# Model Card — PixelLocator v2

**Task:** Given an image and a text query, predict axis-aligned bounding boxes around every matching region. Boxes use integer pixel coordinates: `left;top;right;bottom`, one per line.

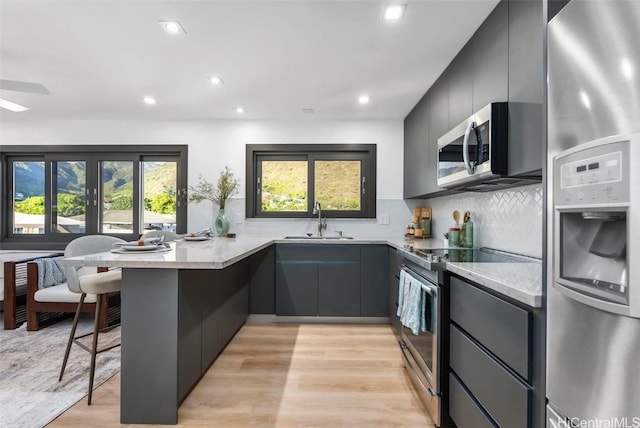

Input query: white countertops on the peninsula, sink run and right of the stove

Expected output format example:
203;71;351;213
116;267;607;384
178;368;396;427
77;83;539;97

64;235;542;307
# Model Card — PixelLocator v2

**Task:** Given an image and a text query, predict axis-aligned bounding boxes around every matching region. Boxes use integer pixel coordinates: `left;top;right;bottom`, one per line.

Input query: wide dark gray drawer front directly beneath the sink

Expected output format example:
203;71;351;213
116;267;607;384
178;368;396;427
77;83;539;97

276;244;360;262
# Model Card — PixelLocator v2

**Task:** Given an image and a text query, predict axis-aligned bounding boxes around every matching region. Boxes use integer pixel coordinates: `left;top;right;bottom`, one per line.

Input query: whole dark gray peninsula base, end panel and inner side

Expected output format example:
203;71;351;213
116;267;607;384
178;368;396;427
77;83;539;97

120;261;249;425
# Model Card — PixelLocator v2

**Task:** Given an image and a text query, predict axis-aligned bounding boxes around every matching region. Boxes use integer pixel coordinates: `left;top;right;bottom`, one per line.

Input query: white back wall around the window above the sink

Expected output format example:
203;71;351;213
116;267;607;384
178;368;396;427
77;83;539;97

0;119;410;236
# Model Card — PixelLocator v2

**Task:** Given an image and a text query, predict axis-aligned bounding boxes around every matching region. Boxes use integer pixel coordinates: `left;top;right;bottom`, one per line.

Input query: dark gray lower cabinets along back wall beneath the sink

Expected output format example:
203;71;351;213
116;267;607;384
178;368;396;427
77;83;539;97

275;244;388;317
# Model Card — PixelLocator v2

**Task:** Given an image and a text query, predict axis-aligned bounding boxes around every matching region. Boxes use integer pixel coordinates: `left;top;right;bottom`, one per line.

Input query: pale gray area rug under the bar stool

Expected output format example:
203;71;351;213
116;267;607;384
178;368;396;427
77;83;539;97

0;318;120;428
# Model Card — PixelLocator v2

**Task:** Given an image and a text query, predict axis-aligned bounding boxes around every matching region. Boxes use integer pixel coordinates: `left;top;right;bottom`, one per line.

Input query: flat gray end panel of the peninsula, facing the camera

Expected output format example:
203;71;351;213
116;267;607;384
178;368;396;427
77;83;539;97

120;269;180;425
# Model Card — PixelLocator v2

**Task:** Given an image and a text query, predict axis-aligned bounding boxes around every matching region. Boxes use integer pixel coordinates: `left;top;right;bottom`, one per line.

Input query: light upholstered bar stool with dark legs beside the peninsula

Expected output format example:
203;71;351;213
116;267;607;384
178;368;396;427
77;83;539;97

58;235;125;405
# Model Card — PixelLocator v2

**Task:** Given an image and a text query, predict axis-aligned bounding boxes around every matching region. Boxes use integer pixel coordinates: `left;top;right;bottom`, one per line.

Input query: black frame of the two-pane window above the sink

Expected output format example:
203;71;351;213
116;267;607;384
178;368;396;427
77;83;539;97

245;144;377;219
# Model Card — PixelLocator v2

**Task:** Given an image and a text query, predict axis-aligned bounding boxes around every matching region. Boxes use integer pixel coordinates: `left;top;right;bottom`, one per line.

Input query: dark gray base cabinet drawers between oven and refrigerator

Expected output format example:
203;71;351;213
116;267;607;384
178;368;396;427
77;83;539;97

449;276;535;428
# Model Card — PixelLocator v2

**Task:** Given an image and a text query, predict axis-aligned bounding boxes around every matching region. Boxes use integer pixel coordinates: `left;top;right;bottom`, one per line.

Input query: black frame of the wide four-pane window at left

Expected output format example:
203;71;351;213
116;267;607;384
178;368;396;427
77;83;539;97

0;144;188;250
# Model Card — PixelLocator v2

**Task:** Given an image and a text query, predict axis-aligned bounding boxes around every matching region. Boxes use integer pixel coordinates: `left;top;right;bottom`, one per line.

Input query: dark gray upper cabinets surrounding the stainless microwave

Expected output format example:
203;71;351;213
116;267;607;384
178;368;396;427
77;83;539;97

404;0;544;198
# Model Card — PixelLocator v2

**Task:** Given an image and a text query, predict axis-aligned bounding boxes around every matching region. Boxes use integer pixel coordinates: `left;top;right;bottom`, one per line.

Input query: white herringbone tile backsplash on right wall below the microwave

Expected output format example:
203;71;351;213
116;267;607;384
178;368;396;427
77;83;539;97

409;184;542;257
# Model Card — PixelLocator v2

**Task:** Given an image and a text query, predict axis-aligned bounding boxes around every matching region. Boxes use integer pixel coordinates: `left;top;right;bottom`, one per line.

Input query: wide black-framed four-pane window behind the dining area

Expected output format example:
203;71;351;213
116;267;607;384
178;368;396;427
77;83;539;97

1;146;187;248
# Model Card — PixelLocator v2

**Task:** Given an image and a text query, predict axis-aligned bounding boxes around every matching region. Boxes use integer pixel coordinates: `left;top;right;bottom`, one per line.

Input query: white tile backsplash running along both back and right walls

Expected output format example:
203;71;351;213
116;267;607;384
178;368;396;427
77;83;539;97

189;184;542;257
